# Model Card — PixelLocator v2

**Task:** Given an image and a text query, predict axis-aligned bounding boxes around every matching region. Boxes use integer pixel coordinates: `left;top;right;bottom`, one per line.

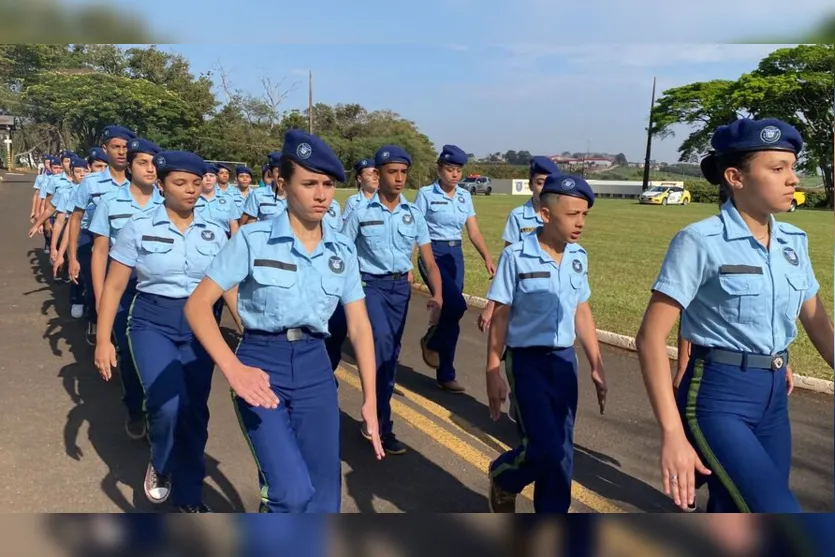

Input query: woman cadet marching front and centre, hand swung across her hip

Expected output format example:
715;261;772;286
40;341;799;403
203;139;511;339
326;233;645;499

185;129;384;513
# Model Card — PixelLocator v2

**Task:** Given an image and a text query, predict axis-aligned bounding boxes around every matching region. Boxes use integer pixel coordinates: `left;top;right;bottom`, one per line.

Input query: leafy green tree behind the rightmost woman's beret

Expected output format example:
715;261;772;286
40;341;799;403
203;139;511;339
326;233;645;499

652;44;835;207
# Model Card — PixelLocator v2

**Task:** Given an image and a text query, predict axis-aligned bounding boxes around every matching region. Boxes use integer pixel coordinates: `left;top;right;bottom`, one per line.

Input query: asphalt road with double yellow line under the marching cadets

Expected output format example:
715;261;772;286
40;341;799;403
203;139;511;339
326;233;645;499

0;175;835;513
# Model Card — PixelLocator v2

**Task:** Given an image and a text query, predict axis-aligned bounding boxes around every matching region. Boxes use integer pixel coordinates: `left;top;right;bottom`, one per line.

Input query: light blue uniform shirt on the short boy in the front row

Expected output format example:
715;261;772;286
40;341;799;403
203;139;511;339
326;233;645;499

487;228;591;348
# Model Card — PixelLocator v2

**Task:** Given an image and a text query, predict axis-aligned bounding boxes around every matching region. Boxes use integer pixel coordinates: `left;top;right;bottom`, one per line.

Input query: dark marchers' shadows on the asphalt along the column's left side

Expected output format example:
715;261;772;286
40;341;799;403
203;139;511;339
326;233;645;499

30;249;244;513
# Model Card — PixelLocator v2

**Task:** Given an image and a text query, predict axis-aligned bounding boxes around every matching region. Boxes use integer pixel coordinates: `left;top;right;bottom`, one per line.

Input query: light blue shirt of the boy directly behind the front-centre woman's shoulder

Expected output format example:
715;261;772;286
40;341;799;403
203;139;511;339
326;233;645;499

342;193;430;275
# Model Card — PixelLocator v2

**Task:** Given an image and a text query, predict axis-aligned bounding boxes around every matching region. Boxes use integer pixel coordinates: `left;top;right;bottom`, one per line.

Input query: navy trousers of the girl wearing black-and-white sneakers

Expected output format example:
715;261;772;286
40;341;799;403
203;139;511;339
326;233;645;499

128;292;214;505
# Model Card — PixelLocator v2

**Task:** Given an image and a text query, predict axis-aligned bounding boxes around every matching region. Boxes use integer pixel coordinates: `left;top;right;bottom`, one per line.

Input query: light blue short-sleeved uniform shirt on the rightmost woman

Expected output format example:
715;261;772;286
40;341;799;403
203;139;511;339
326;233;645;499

652;201;820;355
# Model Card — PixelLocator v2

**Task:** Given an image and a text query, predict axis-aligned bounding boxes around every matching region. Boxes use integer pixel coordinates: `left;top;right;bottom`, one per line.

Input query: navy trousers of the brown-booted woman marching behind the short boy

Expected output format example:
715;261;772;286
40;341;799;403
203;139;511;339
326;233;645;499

418;241;467;383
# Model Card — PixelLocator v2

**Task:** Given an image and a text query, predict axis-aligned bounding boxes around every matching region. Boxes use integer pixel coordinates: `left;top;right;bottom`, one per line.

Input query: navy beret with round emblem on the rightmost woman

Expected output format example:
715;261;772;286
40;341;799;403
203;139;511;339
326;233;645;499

710;118;803;156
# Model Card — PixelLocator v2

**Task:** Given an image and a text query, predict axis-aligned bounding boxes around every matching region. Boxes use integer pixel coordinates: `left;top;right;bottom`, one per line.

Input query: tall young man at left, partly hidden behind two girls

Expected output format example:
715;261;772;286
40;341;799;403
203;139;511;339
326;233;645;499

67;126;136;345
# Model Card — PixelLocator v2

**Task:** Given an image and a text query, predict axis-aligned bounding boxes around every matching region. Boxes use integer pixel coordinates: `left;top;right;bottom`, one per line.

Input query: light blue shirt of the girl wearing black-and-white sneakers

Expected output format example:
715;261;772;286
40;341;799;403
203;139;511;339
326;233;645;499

110;205;227;298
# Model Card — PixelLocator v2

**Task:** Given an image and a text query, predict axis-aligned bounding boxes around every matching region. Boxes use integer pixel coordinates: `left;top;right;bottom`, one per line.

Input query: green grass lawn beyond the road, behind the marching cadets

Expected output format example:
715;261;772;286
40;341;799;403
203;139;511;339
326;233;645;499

337;191;833;380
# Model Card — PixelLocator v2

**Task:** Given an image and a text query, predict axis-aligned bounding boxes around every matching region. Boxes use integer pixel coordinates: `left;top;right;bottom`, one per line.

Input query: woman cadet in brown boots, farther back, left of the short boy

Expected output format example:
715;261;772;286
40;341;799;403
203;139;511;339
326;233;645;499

415;145;496;393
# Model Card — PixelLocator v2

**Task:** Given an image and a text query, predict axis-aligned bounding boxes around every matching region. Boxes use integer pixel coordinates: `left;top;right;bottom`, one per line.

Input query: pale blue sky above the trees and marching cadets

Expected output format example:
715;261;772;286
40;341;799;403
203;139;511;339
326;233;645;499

58;0;833;162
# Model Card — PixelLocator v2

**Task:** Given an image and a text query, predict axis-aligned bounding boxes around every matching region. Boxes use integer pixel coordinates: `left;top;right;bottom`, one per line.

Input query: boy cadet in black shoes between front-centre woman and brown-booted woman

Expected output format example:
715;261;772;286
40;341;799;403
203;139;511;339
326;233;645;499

342;145;443;455
